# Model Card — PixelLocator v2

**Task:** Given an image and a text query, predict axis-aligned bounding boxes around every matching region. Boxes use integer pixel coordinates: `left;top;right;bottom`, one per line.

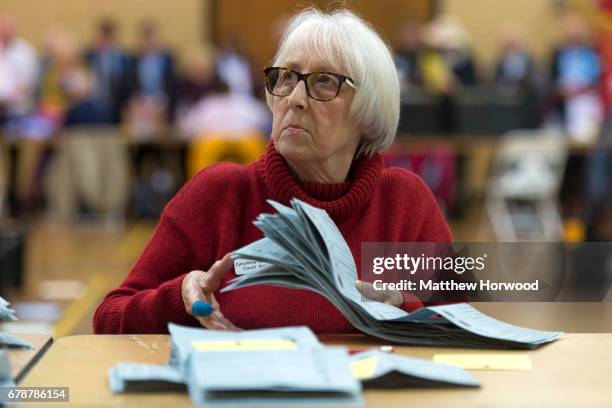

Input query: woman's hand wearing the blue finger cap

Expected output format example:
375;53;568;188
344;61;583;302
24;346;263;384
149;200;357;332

181;254;240;330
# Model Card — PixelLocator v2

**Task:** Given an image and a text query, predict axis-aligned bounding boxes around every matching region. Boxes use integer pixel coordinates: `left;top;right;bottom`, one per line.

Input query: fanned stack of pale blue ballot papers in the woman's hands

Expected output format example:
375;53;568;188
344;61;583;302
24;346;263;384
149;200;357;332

221;199;563;348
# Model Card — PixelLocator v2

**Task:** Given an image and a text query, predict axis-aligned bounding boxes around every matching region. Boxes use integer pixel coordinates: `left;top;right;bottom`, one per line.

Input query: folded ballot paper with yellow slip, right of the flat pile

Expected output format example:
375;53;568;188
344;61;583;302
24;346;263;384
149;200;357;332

351;350;480;388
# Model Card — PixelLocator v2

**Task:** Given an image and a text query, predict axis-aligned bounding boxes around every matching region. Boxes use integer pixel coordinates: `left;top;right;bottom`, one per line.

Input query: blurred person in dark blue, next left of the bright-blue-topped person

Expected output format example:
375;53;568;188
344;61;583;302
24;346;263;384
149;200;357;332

494;23;534;94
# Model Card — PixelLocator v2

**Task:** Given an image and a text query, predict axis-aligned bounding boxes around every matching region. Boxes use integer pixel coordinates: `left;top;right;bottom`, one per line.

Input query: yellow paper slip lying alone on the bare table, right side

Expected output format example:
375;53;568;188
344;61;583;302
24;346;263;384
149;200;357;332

433;353;533;370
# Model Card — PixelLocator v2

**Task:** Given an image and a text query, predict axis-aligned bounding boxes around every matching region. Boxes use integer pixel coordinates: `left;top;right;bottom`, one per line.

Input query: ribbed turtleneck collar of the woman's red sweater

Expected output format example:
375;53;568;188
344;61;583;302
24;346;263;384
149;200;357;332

264;141;383;222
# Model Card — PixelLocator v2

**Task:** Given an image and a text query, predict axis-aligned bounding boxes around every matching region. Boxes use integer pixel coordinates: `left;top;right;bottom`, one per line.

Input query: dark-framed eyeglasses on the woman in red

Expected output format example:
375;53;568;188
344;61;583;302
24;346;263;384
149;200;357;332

264;67;357;102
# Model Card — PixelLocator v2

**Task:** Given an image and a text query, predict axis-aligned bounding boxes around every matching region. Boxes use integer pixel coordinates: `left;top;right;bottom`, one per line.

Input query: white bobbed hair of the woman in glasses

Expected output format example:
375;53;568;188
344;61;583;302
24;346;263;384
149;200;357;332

266;8;400;157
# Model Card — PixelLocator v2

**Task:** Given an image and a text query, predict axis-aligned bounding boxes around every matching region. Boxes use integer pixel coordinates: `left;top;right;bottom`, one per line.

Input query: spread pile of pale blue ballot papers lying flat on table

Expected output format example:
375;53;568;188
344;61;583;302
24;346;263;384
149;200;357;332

109;324;479;406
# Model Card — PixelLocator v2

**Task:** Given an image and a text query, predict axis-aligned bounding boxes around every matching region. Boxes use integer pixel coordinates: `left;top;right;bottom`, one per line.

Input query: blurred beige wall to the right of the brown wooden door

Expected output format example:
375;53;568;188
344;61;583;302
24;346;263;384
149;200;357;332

440;0;560;73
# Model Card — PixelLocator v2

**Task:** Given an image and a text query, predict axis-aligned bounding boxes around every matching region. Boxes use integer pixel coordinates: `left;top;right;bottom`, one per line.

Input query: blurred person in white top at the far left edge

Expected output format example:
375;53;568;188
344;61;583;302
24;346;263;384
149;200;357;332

0;15;38;125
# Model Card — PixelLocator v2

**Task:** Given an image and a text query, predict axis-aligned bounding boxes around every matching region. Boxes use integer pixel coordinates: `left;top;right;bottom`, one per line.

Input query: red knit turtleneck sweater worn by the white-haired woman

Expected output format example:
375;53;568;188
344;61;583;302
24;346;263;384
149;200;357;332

94;143;451;334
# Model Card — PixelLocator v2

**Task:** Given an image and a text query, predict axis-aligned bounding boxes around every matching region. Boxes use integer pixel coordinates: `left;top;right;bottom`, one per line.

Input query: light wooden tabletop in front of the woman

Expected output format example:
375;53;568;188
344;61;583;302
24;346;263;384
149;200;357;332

20;333;612;407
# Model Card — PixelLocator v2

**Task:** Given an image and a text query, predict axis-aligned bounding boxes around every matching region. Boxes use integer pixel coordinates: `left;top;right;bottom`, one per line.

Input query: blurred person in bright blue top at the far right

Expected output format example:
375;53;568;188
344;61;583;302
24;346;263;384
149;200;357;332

551;13;603;141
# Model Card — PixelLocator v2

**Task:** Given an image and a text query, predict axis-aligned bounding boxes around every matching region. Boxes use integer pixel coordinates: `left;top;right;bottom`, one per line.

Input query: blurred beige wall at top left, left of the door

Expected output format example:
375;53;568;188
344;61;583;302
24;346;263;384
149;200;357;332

0;0;210;50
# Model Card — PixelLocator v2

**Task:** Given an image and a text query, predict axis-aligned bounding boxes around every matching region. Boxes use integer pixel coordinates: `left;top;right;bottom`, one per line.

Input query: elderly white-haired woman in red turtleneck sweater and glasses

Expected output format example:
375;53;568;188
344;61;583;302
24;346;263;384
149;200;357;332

94;9;451;333
